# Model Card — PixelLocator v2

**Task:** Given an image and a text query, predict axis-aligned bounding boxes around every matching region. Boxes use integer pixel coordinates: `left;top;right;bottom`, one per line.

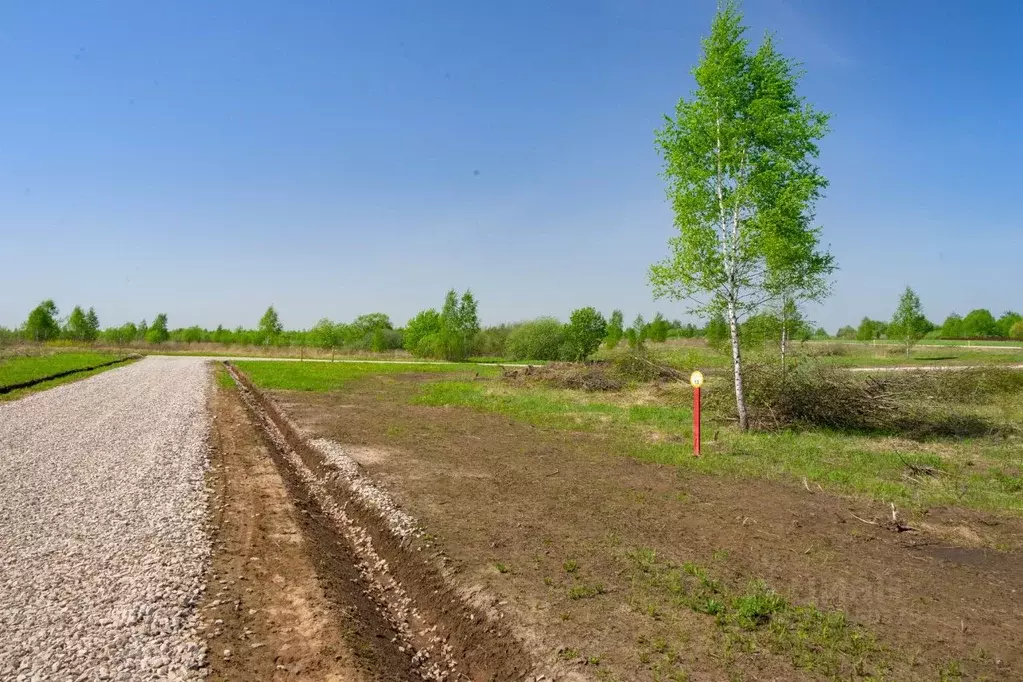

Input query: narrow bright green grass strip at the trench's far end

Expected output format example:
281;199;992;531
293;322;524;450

234;360;499;392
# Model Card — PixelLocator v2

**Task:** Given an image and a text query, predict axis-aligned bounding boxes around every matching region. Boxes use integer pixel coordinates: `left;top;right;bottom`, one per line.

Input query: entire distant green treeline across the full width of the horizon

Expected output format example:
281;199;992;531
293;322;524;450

0;290;1023;360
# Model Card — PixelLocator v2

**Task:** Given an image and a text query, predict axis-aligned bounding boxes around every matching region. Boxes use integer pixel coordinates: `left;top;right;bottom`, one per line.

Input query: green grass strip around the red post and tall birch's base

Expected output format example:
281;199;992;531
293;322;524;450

414;380;1023;512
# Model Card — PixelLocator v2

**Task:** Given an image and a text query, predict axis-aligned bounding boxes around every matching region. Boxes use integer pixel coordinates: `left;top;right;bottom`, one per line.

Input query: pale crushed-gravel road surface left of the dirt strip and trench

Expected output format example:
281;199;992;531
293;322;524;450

0;358;210;681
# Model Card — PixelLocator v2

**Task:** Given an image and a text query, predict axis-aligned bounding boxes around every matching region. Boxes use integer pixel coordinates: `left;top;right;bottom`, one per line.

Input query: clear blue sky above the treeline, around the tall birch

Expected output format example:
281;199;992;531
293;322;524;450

0;0;1023;331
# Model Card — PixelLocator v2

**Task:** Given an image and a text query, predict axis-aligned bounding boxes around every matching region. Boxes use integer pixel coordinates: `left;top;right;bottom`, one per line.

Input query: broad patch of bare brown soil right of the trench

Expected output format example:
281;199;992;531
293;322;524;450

272;374;1023;680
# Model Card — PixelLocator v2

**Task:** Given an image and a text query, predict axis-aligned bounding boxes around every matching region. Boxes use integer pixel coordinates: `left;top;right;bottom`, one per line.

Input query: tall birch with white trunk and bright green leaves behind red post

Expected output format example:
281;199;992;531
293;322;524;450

650;2;833;429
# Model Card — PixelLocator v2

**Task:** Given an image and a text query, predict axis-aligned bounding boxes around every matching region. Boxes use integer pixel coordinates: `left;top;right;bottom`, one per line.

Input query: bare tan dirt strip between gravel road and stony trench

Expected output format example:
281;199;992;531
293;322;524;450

202;376;421;682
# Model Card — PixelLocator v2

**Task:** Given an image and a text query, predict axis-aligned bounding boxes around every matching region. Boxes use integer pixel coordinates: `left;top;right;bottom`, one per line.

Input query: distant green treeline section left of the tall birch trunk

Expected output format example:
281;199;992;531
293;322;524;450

0;290;706;360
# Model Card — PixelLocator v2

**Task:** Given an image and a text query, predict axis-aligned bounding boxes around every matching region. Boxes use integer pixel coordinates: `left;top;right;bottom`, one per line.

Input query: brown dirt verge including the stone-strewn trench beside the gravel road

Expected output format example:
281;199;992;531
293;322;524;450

203;368;537;681
